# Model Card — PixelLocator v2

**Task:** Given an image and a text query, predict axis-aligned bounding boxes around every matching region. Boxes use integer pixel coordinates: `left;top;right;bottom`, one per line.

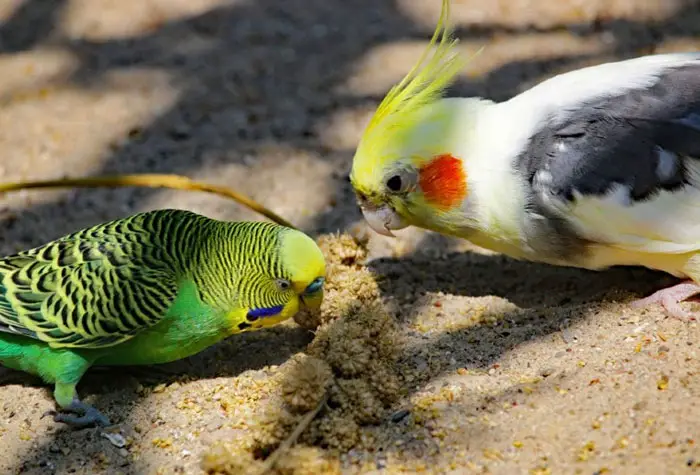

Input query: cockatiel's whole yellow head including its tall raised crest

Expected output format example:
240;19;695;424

350;0;476;236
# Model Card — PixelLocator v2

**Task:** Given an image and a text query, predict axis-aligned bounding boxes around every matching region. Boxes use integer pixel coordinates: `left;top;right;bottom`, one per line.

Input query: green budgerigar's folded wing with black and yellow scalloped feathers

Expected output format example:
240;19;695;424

0;215;178;348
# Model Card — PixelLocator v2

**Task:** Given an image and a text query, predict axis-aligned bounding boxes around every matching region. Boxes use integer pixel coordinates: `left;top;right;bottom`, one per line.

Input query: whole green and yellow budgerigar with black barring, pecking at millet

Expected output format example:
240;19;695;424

0;210;325;427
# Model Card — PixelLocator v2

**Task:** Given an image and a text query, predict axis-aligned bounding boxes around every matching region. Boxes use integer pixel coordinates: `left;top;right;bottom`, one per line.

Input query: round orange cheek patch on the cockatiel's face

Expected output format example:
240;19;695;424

418;154;467;208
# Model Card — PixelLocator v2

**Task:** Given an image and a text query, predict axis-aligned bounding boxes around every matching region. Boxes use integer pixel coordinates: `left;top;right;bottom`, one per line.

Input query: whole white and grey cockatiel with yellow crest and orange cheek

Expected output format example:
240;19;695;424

350;0;700;319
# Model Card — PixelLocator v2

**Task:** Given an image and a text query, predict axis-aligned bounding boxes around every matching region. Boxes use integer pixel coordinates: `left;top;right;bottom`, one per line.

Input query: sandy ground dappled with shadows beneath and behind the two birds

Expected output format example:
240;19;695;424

0;0;700;474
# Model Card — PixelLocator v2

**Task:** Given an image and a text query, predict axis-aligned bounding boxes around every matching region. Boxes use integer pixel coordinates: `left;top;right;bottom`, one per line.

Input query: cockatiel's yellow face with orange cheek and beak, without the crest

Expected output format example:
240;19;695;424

350;100;467;236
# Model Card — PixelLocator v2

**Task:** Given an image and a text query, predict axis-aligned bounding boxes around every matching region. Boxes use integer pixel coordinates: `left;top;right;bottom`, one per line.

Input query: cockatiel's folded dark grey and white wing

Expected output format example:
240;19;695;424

521;54;700;254
